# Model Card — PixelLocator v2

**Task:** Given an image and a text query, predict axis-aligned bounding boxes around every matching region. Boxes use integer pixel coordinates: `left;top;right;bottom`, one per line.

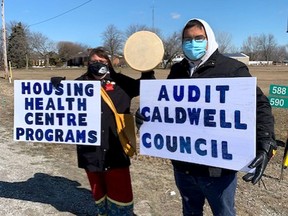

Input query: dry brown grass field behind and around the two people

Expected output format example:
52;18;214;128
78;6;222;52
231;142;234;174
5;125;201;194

0;66;288;216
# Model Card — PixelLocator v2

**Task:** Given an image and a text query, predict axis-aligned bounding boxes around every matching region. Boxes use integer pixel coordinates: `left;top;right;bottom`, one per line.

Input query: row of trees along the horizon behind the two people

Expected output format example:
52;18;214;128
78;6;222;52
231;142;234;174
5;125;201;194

0;22;288;68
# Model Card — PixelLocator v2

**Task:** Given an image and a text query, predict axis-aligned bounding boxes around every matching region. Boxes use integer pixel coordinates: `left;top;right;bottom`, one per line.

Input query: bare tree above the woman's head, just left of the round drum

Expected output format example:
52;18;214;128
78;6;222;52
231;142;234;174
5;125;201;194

102;24;123;58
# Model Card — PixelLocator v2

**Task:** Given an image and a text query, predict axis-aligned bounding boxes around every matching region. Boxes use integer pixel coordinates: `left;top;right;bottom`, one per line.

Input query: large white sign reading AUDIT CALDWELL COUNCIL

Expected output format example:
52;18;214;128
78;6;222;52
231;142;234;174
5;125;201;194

140;77;256;171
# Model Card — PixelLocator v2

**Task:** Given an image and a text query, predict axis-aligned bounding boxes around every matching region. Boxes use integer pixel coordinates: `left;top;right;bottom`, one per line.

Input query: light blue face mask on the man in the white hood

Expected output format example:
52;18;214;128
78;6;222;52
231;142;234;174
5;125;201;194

182;40;207;61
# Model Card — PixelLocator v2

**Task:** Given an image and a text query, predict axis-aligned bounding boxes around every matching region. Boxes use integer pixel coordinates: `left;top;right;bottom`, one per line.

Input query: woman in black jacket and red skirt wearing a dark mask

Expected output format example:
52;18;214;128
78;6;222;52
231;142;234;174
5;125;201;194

77;48;154;216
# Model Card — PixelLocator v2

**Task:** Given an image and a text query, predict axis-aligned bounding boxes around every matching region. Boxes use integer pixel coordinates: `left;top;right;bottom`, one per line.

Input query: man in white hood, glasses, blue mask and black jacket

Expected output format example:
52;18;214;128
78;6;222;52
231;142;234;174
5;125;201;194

168;19;276;216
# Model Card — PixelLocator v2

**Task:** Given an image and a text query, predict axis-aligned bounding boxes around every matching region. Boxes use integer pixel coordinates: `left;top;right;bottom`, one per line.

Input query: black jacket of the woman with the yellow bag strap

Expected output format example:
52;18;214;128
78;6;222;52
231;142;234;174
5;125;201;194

77;73;140;172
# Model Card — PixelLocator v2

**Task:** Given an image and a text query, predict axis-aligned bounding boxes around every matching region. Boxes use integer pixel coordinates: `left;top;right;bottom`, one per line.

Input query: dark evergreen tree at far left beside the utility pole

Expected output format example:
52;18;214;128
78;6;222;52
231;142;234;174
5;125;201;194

7;22;28;68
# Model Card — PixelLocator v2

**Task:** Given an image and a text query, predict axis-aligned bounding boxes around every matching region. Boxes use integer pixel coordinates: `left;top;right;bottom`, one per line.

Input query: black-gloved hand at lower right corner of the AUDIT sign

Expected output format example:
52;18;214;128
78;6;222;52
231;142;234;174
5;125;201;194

242;139;277;184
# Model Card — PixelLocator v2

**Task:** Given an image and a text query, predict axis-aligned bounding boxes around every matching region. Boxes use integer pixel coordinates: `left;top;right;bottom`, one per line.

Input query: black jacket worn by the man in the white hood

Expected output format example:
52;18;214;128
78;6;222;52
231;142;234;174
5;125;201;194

168;50;274;176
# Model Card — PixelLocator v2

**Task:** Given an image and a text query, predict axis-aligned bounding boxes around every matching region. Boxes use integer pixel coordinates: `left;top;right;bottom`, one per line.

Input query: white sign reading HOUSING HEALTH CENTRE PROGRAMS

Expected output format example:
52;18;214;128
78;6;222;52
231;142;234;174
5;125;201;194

14;80;101;145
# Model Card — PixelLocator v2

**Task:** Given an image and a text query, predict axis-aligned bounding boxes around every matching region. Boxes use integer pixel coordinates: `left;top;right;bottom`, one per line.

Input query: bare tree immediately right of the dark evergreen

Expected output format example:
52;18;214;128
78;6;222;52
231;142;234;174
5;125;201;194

29;32;56;67
